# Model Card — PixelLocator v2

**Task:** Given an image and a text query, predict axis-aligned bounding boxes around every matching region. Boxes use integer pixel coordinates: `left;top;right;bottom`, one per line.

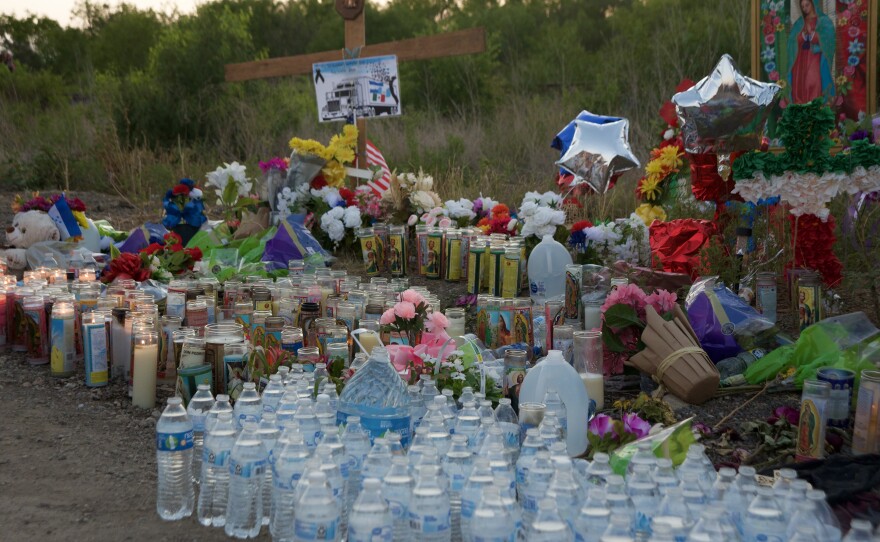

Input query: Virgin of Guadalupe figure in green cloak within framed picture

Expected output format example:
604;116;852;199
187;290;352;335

788;0;837;104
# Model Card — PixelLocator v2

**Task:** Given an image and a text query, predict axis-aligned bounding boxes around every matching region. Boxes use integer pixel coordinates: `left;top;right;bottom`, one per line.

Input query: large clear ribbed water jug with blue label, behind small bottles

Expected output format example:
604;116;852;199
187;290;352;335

337;346;410;448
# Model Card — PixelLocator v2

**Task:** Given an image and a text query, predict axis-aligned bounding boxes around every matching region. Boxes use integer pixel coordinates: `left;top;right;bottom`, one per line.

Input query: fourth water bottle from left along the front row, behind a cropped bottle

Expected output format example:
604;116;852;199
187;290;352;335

269;427;312;542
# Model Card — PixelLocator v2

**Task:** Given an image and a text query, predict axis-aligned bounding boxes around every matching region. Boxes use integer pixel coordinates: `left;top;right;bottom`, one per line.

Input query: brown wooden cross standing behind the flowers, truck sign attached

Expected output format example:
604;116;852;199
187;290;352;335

226;0;486;168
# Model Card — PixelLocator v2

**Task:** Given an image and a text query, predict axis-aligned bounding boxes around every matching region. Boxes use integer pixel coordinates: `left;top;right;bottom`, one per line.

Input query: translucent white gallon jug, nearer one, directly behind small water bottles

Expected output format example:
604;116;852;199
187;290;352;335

519;350;590;457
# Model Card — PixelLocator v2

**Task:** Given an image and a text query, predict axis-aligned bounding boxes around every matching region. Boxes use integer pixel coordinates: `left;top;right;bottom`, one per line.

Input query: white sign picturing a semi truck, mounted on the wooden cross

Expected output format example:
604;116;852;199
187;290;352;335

312;55;400;122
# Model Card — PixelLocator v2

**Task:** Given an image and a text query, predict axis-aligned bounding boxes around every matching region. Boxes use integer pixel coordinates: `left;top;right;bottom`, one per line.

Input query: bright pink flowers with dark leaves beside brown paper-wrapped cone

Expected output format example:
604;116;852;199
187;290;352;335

601;284;677;376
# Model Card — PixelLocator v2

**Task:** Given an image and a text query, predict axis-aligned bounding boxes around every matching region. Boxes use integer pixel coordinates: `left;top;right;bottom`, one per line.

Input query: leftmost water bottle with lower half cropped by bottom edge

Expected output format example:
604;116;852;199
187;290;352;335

293;471;339;542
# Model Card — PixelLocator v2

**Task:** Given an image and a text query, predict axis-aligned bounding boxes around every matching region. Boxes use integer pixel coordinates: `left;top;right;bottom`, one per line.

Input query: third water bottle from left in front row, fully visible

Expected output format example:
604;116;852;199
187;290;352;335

224;422;269;538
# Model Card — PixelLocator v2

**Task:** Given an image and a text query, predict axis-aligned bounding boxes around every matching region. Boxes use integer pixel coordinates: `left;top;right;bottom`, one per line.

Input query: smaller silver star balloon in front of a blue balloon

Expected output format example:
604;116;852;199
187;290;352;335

556;119;639;194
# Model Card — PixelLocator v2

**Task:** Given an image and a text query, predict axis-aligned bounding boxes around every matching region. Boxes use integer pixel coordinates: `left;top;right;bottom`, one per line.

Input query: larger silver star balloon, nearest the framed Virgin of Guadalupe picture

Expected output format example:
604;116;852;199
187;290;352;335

672;55;780;178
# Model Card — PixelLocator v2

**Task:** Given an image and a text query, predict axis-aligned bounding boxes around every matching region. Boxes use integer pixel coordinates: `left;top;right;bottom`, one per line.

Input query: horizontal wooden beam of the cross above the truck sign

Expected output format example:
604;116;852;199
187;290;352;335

226;28;486;82
